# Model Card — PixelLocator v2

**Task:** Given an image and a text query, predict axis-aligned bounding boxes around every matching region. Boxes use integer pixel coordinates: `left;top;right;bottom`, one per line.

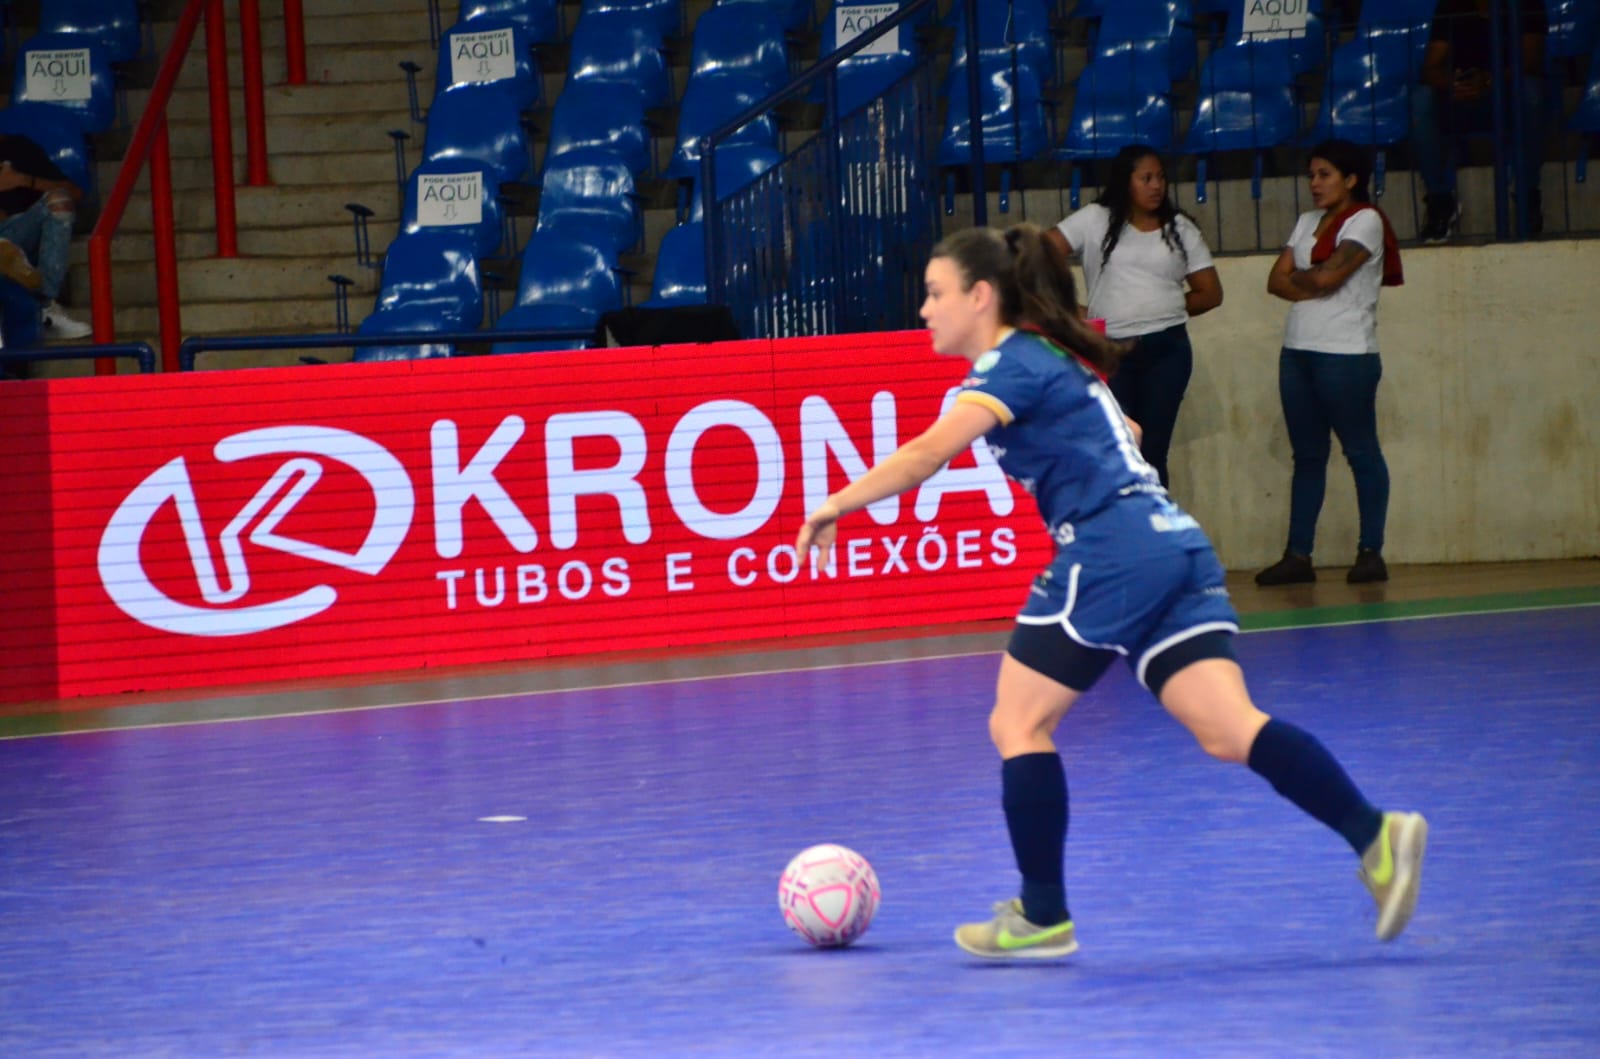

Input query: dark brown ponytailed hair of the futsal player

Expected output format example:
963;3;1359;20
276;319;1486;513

933;224;1133;376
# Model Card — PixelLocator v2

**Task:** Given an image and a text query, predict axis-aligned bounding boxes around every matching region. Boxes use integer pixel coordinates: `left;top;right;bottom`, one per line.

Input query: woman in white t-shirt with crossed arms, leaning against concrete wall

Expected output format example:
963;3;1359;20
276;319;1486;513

1256;139;1403;585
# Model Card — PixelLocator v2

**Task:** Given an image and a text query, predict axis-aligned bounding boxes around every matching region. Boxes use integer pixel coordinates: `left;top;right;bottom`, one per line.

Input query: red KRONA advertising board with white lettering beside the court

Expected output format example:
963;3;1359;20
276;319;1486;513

0;331;1048;702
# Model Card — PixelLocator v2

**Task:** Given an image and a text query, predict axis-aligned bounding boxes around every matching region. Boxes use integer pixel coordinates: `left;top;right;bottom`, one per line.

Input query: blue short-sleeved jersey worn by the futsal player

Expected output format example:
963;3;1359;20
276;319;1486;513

957;331;1210;552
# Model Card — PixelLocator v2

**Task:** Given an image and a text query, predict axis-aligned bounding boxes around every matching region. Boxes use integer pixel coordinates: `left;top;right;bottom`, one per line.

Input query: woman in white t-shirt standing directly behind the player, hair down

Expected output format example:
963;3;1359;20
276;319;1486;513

1045;144;1222;486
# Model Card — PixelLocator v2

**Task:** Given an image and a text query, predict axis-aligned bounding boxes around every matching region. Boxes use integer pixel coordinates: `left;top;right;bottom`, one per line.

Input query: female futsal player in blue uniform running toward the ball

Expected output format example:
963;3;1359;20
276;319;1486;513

795;224;1427;958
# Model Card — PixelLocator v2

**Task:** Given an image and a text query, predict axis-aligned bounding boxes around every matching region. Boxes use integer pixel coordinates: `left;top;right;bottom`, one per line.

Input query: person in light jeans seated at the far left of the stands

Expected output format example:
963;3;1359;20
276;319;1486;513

0;134;93;339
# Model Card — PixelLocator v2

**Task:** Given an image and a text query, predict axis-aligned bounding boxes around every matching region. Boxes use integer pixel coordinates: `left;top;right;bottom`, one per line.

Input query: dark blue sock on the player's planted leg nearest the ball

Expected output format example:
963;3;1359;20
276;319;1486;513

1000;752;1069;926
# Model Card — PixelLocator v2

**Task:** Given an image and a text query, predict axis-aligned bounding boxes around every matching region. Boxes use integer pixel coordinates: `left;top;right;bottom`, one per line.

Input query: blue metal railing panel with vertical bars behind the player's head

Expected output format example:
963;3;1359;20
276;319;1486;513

696;0;966;338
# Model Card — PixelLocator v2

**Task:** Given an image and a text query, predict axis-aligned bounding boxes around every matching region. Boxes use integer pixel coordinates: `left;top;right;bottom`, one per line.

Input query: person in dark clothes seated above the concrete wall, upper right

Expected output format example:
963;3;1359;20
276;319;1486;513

1411;0;1549;243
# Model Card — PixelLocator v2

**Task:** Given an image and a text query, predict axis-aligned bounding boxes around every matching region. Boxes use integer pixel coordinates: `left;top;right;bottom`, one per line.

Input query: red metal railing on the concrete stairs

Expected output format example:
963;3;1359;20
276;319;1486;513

90;0;306;374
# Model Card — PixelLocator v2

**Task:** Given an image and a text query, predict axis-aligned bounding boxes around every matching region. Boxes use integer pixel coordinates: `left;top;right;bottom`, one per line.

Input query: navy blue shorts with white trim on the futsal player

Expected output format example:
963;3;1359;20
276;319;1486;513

1006;547;1238;694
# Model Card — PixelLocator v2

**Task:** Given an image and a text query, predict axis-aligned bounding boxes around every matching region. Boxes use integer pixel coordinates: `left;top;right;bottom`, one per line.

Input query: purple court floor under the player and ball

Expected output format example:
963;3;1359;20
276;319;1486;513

0;606;1600;1057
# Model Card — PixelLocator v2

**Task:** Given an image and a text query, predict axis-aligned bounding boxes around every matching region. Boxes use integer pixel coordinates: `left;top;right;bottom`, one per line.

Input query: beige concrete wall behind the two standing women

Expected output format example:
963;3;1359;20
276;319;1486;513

1171;240;1600;569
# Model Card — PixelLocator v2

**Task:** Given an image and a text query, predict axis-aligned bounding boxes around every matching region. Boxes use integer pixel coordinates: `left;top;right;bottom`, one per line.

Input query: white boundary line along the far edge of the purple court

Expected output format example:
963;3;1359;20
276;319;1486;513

0;600;1600;742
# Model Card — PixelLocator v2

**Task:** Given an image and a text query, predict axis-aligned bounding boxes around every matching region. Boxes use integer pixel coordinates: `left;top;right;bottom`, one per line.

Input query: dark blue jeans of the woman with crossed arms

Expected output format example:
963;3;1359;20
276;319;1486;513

1278;349;1389;555
